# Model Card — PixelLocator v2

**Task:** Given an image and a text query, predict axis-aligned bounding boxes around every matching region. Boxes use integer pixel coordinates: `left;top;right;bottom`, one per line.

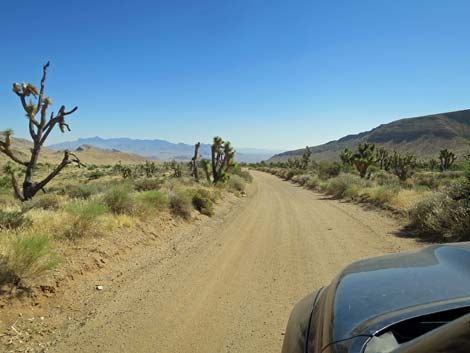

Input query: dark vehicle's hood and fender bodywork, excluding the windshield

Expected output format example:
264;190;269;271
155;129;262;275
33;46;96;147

282;242;470;353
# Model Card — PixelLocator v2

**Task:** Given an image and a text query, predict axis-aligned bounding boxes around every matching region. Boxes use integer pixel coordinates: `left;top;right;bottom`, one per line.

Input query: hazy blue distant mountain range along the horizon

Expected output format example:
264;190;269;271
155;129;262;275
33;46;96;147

48;137;280;163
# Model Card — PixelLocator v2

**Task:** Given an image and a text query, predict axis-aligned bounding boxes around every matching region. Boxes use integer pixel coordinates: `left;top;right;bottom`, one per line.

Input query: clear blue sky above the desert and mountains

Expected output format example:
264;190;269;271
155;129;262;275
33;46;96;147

0;0;470;149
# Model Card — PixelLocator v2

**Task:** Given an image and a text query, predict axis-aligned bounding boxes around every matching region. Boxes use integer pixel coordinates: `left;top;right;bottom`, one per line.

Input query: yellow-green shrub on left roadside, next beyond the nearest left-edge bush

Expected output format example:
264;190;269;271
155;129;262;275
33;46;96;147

60;201;109;240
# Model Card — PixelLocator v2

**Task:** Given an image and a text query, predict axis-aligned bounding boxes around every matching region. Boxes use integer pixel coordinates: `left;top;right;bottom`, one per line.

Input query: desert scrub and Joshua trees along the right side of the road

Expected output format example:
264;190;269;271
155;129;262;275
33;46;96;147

252;143;470;241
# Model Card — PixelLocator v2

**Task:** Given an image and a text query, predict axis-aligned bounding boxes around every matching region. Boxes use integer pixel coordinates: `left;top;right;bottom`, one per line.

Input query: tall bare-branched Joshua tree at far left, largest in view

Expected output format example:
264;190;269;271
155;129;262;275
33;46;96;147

0;62;83;201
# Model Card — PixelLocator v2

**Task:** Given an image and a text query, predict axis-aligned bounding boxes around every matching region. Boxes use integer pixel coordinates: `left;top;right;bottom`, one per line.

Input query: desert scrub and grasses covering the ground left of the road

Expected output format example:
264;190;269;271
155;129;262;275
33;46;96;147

0;128;251;286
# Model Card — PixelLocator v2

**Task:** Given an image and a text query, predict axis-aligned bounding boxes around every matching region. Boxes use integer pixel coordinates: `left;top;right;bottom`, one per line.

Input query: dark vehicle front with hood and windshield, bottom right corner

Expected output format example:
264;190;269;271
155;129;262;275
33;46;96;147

282;243;470;353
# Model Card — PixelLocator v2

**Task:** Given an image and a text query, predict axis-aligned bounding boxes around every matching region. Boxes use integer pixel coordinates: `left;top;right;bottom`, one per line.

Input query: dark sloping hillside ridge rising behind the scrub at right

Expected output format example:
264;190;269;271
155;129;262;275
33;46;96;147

269;110;470;161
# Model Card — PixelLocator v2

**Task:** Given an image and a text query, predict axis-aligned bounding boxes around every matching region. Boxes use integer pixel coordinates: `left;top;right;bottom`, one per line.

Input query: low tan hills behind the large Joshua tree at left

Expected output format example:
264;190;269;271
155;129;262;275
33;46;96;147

0;135;147;164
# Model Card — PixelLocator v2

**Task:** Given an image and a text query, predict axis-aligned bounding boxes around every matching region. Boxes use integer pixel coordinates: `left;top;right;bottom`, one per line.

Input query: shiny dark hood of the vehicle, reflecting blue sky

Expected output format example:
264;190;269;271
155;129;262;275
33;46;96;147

329;243;470;341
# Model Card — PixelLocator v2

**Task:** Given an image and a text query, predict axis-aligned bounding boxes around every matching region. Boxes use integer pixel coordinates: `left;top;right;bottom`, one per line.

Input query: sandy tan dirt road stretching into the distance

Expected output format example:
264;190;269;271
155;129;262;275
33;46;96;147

51;172;418;353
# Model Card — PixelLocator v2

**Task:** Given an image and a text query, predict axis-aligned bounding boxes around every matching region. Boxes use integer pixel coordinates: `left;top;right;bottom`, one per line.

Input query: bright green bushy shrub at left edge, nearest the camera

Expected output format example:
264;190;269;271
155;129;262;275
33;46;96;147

0;234;60;285
